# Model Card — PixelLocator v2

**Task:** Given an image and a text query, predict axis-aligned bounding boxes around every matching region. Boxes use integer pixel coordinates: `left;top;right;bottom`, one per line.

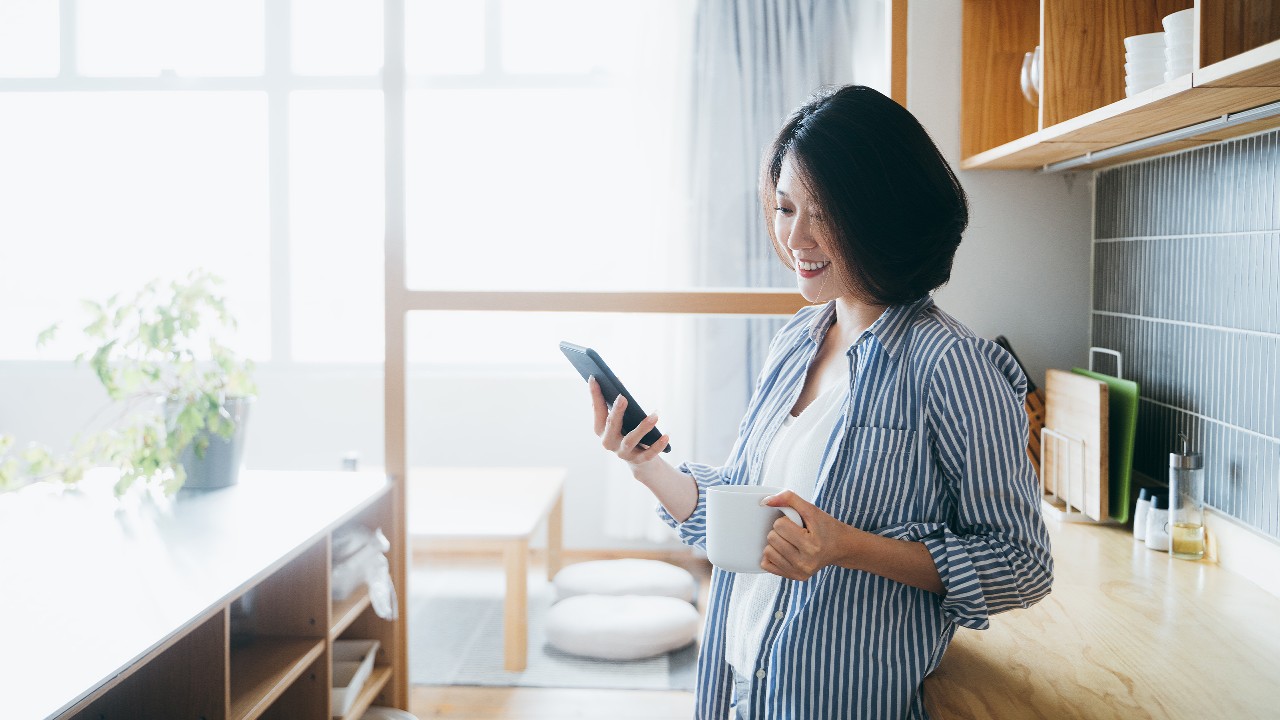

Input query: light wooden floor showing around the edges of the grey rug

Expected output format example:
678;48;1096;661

408;551;710;720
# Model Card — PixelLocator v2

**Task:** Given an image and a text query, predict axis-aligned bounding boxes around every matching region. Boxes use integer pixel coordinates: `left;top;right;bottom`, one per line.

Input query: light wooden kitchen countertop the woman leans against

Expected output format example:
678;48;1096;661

924;512;1280;720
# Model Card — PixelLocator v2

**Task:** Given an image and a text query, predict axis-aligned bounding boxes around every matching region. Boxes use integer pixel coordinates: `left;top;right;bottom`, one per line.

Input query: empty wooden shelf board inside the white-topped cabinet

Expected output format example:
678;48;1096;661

228;638;325;720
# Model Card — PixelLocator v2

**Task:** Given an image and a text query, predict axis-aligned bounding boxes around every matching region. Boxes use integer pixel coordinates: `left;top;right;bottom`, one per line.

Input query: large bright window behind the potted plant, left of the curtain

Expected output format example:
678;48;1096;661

0;0;691;363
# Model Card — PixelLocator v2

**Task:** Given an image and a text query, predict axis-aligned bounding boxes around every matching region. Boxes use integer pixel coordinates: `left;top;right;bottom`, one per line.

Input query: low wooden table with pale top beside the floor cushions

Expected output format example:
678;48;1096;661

408;468;566;671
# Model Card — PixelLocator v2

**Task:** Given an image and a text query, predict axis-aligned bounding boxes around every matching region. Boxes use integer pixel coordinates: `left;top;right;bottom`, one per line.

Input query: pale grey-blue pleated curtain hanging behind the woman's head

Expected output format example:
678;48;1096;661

691;0;888;462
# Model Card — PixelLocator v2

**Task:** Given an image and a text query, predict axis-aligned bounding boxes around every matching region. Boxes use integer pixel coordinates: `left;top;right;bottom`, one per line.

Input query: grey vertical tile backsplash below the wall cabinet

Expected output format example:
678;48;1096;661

1092;132;1280;538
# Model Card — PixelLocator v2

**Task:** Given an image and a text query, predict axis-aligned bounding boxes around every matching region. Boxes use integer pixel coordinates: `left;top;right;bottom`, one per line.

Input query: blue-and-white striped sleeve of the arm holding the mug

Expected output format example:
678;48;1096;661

926;338;1053;629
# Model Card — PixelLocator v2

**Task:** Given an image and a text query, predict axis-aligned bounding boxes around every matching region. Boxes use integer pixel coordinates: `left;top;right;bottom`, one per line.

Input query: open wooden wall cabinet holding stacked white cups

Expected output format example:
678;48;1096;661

961;0;1280;169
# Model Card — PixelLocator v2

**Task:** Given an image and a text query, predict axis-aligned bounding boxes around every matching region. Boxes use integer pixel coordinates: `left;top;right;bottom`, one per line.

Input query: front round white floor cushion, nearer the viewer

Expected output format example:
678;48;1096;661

547;594;699;660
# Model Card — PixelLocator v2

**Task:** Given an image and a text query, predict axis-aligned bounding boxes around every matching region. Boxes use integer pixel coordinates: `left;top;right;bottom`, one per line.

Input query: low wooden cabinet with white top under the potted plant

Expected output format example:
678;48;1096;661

0;473;407;720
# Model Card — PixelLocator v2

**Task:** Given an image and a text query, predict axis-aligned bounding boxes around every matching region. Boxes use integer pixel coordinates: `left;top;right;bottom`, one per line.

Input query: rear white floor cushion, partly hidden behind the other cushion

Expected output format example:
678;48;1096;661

553;559;698;602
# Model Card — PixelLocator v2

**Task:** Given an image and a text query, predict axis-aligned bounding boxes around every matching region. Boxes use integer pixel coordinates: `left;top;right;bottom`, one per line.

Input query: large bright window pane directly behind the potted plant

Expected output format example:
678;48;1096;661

0;92;270;359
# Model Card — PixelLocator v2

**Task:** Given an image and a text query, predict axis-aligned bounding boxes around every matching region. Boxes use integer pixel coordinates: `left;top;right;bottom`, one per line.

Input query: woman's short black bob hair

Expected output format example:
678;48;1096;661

760;86;969;305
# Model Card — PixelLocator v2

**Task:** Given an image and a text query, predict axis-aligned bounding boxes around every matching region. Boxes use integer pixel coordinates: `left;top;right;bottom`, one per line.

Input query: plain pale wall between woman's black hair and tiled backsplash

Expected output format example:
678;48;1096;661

906;0;1093;386
